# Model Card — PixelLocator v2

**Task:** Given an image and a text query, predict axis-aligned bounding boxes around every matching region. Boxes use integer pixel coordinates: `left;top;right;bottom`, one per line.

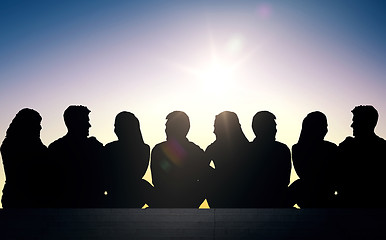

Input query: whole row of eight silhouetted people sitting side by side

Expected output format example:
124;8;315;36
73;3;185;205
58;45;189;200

1;105;386;208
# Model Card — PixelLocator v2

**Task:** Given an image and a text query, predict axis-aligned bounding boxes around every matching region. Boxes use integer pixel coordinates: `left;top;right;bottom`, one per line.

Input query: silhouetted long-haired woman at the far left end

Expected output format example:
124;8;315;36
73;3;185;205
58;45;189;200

1;108;49;208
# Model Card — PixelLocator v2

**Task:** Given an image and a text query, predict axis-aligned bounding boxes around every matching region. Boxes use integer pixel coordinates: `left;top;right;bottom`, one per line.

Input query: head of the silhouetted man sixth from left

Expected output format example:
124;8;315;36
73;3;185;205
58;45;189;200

252;111;277;141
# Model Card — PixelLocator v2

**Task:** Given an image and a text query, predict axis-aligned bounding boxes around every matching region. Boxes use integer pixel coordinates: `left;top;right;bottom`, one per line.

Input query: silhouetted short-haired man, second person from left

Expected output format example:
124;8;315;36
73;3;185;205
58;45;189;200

48;105;105;208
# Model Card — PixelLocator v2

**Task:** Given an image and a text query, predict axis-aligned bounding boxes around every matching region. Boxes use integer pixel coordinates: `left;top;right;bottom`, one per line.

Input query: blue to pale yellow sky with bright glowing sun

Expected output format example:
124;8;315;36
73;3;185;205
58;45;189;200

0;0;386;208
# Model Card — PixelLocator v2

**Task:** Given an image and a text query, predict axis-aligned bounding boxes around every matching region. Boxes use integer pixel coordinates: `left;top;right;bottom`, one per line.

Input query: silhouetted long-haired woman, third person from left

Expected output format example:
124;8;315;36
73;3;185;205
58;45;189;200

105;112;152;208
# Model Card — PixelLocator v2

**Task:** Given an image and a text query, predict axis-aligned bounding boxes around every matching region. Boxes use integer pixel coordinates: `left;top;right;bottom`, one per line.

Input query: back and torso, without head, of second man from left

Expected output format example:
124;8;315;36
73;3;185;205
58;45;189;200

48;136;103;208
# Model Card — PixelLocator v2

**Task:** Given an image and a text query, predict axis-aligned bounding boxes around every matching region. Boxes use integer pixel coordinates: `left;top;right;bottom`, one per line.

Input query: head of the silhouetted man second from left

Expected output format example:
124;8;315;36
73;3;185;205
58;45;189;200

63;105;91;137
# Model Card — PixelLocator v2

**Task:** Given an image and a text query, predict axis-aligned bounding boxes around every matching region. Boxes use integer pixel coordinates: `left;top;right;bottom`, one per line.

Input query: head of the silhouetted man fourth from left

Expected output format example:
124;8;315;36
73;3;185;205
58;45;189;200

165;111;190;139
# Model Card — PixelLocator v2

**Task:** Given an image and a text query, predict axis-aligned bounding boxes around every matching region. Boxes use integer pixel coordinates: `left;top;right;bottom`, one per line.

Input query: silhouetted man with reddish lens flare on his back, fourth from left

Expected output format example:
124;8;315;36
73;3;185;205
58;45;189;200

150;111;209;208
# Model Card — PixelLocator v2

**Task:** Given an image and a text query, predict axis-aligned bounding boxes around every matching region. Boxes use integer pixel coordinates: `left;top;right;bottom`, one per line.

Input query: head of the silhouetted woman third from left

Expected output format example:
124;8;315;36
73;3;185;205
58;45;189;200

114;111;143;142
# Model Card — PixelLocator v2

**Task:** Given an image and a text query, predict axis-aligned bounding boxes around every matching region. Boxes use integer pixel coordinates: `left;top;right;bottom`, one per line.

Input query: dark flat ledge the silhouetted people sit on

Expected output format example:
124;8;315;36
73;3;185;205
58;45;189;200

0;209;386;239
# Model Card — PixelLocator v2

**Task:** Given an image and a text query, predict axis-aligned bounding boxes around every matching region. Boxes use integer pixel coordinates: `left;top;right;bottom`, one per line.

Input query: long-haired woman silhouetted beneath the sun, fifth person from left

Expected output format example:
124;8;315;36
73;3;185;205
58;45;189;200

205;111;249;208
